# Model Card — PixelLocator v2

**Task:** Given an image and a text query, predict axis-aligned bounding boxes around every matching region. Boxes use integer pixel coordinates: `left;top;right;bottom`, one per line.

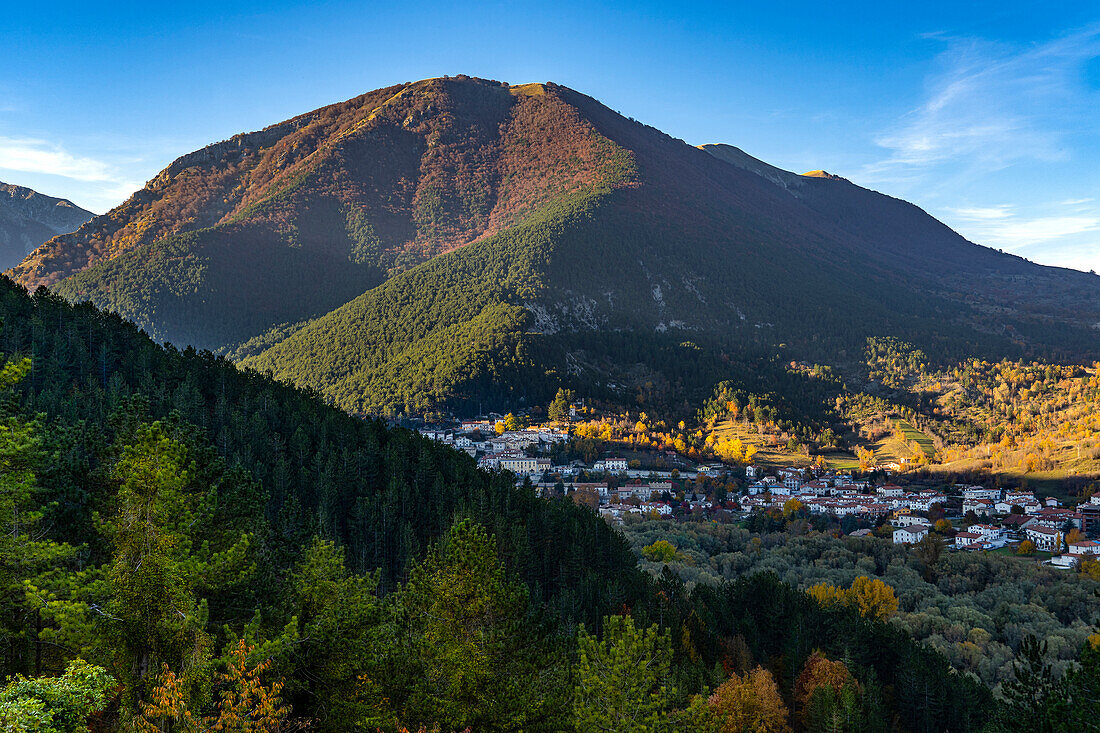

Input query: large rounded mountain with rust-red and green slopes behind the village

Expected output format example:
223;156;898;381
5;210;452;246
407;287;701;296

12;77;1100;414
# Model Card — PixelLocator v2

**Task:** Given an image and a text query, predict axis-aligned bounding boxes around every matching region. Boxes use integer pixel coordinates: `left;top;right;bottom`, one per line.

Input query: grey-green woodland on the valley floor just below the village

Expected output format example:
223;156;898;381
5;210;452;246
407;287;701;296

625;521;1100;688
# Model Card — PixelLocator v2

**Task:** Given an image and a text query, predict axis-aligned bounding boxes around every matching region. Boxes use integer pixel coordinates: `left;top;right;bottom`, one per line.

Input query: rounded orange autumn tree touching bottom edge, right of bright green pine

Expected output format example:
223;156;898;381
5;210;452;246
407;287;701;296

707;667;791;733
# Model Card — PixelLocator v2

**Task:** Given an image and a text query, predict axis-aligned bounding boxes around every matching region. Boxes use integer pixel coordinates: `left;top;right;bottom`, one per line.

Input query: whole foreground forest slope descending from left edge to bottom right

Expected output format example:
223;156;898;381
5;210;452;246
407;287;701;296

0;281;1097;732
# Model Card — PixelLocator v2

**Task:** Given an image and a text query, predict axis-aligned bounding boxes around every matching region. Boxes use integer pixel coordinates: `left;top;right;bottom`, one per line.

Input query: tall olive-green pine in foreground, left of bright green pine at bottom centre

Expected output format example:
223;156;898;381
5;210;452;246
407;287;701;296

394;519;564;732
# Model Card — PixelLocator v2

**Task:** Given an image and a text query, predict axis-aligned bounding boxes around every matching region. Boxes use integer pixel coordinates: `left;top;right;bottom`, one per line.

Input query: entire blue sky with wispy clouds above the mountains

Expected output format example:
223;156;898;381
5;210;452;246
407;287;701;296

0;0;1100;271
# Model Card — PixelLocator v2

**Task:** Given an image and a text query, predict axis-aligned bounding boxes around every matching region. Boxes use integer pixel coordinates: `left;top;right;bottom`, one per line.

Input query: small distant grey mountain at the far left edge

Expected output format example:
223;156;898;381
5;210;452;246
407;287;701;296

0;183;95;270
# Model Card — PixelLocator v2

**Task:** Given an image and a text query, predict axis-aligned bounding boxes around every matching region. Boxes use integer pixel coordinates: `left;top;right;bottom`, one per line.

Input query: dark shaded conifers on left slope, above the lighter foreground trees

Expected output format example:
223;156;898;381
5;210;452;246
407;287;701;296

0;274;646;633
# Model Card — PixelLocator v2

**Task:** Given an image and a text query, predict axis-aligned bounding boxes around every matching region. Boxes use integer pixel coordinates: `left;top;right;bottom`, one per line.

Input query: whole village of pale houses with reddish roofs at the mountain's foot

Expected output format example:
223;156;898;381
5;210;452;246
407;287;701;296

419;415;1100;569
